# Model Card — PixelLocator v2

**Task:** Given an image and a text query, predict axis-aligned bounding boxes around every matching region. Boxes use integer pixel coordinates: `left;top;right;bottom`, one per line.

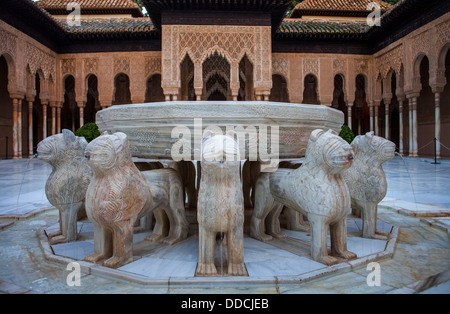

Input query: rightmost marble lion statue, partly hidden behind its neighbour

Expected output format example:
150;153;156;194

343;132;395;240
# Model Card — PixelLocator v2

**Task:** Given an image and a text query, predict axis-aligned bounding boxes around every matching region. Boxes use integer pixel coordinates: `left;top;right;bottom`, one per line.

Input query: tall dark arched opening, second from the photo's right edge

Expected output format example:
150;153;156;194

417;56;435;156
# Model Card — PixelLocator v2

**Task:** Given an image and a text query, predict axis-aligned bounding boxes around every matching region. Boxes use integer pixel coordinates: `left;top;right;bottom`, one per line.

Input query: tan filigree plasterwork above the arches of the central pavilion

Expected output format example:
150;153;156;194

162;25;272;90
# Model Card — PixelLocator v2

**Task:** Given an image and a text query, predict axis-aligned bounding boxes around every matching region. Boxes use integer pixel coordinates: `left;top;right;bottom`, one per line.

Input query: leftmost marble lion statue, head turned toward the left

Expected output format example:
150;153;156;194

37;130;93;244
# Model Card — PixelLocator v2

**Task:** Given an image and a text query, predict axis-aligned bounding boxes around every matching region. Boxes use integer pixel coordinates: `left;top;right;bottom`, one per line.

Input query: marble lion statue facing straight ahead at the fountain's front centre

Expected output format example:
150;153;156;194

196;131;247;276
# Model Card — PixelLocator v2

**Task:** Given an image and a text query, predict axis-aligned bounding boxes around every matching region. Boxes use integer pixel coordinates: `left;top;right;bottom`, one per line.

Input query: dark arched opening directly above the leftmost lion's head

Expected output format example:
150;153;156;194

61;75;80;132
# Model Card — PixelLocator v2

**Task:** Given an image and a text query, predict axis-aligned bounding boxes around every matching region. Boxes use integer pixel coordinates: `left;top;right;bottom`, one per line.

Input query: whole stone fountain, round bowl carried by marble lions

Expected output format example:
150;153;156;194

37;101;392;276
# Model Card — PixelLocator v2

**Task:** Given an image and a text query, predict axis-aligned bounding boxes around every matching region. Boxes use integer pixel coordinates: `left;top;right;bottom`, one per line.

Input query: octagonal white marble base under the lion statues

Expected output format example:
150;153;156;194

39;217;398;286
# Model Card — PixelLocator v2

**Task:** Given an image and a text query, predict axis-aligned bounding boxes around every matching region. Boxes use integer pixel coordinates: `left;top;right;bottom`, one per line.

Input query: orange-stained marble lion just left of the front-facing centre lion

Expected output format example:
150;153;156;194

85;132;187;268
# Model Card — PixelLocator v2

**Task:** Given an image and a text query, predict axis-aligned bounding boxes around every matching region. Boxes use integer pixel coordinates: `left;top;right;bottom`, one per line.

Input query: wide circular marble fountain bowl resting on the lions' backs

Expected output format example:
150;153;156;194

96;101;344;160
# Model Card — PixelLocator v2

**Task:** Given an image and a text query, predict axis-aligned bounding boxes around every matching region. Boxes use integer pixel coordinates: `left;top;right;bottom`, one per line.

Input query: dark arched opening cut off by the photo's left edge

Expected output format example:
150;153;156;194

0;56;13;158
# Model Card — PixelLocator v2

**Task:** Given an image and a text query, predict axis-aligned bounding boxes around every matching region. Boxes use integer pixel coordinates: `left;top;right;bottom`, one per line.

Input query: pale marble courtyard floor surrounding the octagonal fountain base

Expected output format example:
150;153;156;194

0;157;450;294
